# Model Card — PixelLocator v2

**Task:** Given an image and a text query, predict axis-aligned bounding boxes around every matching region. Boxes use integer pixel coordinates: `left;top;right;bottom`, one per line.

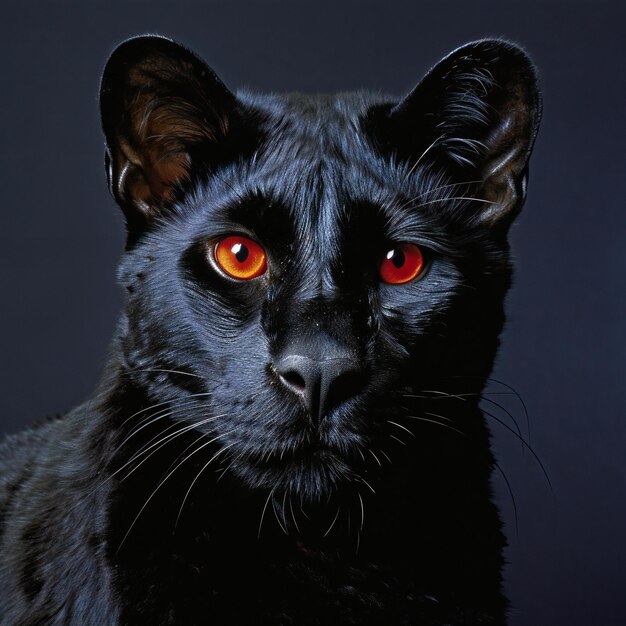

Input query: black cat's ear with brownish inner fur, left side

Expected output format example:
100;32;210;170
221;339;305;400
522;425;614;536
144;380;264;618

100;36;237;234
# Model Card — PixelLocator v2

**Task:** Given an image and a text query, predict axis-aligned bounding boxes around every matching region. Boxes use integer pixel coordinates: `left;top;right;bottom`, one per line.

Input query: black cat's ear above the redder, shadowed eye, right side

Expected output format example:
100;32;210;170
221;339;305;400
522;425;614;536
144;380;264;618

368;40;541;229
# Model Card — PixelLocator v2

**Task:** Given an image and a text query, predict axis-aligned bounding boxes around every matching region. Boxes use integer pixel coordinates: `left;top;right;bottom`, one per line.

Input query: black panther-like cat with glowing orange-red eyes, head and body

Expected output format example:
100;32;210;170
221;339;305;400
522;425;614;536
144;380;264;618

0;37;541;626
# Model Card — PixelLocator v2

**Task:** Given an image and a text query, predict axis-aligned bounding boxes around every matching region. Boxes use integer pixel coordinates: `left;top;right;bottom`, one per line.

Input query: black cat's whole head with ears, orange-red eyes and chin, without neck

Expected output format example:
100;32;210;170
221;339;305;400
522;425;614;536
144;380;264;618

102;37;539;500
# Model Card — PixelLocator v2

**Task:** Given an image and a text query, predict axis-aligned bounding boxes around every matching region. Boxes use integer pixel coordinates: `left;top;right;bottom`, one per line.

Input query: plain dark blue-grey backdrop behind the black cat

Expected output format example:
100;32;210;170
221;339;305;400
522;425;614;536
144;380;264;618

0;0;626;626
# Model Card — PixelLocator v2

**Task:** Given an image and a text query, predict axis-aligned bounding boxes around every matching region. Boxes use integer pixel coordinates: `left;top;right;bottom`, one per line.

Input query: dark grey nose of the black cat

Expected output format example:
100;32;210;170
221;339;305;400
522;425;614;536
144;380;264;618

274;350;365;423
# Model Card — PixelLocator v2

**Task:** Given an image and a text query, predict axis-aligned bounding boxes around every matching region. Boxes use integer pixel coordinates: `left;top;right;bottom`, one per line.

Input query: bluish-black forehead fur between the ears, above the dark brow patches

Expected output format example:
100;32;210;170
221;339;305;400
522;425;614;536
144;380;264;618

229;92;420;209
